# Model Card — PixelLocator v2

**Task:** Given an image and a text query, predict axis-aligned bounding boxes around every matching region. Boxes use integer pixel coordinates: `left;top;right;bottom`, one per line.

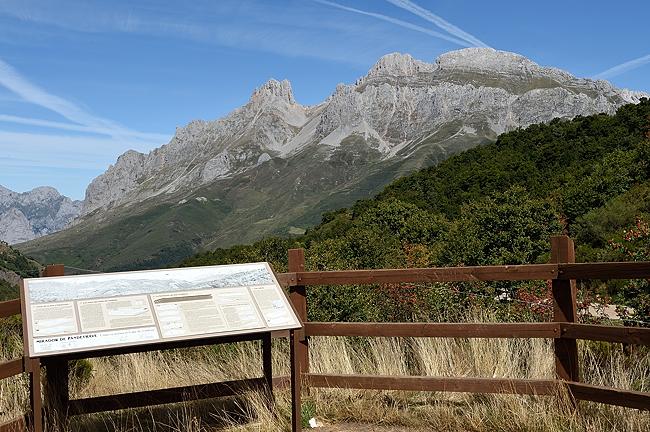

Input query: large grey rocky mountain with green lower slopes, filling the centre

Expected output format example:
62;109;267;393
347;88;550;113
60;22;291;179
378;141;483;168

20;48;643;270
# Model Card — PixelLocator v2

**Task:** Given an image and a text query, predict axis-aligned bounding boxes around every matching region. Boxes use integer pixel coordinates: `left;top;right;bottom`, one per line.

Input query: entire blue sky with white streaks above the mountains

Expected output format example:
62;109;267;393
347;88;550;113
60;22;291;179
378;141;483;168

0;0;650;198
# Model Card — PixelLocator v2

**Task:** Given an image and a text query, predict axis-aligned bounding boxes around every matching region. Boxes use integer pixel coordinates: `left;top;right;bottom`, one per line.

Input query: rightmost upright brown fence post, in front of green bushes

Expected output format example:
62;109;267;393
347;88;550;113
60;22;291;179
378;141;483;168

551;235;580;382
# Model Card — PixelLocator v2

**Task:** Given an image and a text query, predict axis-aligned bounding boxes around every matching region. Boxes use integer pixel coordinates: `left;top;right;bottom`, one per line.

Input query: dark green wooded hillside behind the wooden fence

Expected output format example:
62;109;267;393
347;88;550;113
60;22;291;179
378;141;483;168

176;99;650;320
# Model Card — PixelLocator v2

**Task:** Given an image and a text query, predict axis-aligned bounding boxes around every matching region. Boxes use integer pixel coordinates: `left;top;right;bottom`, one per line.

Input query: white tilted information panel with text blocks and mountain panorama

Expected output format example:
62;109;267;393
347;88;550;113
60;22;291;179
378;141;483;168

23;263;302;357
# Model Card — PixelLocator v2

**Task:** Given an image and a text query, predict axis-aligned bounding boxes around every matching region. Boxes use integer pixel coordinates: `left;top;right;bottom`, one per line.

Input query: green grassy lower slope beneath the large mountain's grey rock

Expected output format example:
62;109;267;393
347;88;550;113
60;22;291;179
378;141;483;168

19;130;485;270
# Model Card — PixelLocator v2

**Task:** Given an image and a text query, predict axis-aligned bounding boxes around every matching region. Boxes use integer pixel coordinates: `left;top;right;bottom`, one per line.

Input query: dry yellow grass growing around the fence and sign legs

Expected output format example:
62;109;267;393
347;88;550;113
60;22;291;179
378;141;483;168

0;316;650;432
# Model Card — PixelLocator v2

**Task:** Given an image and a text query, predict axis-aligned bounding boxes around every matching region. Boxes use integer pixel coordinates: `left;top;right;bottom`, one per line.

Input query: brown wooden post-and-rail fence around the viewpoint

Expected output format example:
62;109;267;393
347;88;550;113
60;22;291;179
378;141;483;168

0;236;650;432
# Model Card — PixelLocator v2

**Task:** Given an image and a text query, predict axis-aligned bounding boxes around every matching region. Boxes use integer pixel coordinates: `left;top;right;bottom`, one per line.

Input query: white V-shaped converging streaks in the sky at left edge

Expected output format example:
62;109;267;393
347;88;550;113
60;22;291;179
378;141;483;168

0;55;163;144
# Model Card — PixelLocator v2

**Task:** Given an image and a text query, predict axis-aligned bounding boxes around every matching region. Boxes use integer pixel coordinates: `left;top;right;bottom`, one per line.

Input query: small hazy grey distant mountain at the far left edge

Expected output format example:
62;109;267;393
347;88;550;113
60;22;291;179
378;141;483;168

0;185;82;244
